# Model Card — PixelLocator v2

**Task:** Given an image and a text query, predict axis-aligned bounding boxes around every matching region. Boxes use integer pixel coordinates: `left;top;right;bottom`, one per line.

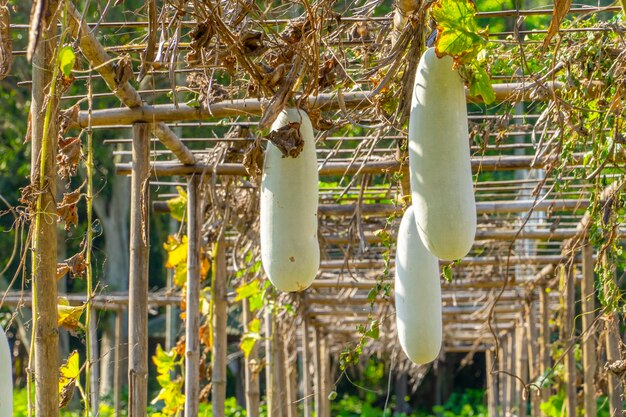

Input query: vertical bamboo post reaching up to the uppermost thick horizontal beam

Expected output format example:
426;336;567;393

128;123;150;417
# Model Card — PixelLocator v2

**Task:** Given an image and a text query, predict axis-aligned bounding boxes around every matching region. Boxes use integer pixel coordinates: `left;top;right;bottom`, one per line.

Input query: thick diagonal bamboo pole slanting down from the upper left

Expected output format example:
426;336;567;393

67;2;196;164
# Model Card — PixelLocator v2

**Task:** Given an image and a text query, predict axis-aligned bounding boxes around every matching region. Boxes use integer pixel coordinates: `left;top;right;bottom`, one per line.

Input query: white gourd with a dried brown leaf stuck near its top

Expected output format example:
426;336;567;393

260;109;320;291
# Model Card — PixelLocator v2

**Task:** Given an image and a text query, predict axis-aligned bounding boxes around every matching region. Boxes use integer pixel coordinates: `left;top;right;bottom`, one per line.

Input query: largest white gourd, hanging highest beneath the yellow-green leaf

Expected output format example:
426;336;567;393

409;48;476;260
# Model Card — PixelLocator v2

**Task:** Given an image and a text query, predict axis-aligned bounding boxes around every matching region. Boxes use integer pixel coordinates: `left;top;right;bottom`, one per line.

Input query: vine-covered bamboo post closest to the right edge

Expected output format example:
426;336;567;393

602;256;624;417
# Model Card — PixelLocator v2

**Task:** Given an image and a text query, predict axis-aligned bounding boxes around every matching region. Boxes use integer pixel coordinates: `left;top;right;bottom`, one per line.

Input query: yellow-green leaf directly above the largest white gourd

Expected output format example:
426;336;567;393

432;0;488;65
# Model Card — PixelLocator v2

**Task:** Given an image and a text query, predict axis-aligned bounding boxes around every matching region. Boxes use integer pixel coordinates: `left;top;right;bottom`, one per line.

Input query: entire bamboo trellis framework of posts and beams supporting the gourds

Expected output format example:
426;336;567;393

1;2;623;417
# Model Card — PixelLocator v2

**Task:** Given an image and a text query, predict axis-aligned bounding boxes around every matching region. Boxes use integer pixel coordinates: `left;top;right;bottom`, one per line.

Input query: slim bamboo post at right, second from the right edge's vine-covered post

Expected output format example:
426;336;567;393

561;265;576;417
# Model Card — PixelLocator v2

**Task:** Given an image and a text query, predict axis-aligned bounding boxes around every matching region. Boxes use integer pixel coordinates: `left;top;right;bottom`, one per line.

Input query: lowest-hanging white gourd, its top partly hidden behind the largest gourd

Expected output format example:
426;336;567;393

395;206;442;364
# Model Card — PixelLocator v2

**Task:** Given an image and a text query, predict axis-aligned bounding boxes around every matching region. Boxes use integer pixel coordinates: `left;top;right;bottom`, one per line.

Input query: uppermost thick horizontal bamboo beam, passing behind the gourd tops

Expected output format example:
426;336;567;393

75;82;564;128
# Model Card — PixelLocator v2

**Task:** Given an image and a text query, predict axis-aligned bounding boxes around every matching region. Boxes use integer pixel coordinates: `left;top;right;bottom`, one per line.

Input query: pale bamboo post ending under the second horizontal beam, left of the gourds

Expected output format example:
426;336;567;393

185;175;202;417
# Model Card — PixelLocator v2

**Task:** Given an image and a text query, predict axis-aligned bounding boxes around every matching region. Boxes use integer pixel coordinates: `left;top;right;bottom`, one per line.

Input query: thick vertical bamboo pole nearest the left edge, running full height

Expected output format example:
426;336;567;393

28;1;59;417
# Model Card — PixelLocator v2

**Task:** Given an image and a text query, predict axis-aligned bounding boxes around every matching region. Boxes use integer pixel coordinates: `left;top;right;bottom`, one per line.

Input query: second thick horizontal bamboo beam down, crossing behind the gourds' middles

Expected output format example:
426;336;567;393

115;154;583;177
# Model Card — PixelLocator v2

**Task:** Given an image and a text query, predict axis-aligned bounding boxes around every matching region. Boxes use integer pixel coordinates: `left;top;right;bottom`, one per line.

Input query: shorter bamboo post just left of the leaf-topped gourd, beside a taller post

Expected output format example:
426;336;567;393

211;233;228;416
